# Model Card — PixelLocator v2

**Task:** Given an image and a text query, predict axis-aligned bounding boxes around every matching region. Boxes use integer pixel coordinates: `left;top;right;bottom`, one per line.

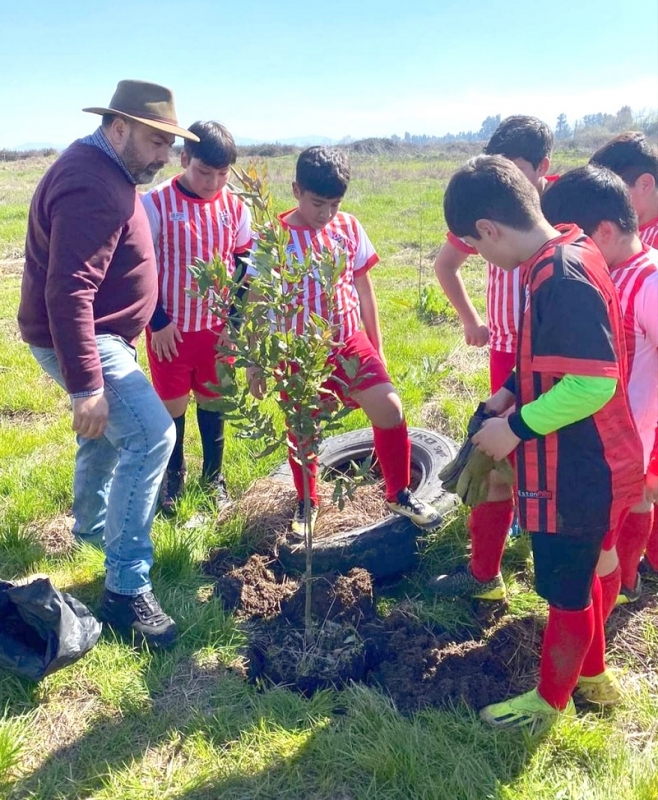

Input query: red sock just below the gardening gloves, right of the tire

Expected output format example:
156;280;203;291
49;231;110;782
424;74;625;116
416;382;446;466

468;497;514;581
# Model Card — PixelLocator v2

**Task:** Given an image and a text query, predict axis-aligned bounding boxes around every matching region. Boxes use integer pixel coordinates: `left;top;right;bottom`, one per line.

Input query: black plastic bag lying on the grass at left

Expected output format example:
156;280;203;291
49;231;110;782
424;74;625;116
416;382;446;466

0;576;102;681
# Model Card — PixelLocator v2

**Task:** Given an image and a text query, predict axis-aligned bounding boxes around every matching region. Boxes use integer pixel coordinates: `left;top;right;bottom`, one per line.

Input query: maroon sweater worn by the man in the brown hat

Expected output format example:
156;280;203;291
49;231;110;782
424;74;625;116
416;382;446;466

18;142;158;394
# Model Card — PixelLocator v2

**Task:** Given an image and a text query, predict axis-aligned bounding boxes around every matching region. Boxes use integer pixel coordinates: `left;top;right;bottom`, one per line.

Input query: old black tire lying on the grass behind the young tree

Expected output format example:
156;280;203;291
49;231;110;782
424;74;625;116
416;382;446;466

271;428;458;578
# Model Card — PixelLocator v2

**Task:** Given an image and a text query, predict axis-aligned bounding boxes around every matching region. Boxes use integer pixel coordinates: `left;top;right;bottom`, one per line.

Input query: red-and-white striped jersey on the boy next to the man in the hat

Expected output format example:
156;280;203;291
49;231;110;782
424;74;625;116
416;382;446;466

142;177;253;332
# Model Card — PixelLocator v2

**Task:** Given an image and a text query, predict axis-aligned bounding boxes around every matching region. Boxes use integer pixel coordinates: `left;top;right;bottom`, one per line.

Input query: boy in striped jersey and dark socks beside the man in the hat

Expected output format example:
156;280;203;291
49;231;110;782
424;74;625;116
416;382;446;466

143;122;252;514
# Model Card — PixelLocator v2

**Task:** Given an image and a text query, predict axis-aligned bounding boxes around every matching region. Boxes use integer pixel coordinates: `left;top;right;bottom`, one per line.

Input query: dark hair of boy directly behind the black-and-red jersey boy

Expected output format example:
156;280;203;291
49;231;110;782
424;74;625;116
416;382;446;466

541;164;637;236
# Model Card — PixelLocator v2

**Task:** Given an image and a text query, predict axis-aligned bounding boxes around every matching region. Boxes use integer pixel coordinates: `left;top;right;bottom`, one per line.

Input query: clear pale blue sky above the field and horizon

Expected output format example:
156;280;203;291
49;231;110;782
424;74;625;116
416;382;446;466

0;0;658;148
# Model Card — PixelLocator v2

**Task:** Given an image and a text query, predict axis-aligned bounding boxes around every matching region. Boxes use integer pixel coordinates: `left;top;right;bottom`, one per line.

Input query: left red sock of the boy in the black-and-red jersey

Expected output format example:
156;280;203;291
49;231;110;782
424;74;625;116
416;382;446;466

537;603;594;709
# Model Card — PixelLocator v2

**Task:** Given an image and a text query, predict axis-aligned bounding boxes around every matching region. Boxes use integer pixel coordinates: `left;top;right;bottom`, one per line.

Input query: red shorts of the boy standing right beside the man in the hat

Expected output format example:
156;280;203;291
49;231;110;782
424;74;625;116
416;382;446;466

146;328;228;400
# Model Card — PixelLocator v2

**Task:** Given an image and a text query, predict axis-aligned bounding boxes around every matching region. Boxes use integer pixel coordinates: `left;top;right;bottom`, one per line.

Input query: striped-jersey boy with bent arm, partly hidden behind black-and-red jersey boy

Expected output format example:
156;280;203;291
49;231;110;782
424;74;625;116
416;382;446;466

432;116;557;600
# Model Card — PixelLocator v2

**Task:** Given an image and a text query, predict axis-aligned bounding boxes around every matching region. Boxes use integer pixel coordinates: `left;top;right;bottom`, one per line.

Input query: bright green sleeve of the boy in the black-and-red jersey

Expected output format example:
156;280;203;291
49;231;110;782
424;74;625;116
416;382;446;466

521;375;617;438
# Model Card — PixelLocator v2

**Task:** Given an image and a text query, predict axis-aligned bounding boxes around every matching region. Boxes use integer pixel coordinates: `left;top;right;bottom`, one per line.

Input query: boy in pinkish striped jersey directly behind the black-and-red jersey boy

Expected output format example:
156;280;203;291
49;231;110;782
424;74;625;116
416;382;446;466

542;164;658;613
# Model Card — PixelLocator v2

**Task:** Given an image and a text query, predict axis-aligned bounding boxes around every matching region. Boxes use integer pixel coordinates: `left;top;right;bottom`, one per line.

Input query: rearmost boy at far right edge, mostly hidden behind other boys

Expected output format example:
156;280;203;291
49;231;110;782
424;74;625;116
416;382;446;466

590;131;658;580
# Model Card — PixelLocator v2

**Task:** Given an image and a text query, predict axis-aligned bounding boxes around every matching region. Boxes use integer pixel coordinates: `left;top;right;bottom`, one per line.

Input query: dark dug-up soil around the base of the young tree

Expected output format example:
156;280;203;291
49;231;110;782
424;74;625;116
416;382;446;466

213;553;541;712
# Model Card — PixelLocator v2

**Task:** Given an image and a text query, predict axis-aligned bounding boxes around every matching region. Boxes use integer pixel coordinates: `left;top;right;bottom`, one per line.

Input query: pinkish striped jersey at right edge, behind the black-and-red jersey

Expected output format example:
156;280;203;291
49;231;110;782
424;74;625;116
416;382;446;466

610;245;658;469
